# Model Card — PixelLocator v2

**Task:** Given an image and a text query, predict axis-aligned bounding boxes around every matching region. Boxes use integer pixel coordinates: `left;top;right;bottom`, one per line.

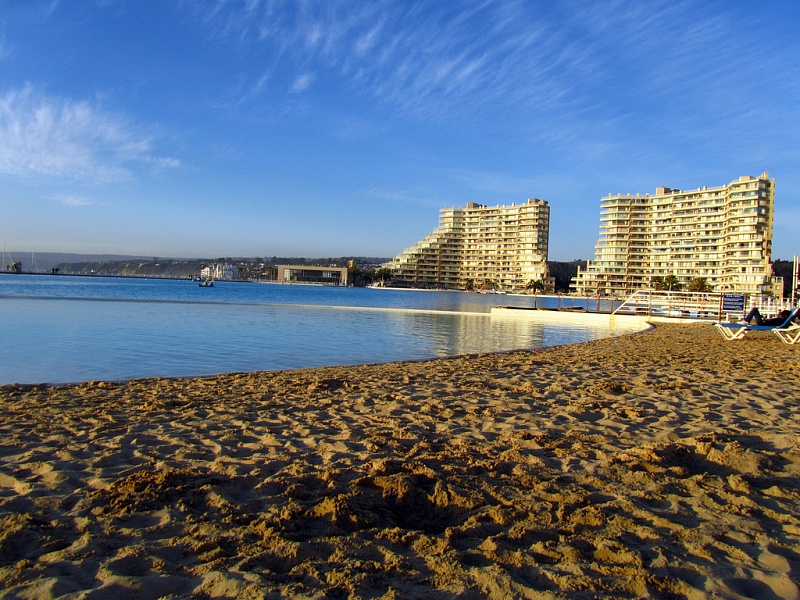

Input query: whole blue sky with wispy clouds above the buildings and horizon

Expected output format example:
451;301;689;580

0;0;800;260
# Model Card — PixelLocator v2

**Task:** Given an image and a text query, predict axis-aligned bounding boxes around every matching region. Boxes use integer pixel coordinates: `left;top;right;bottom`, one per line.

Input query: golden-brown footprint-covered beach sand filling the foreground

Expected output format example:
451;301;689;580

0;324;800;600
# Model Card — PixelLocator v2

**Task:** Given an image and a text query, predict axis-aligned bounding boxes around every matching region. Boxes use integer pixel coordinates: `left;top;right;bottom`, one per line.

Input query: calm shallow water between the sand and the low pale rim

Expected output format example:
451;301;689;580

0;298;636;384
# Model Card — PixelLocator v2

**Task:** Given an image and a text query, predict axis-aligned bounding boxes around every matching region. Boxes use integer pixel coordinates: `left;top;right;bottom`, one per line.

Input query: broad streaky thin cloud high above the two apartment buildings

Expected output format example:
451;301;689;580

192;0;798;156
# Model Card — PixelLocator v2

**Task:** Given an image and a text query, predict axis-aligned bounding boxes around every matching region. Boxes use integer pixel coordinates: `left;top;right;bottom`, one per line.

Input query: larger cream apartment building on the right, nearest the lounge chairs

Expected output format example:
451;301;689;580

572;173;775;296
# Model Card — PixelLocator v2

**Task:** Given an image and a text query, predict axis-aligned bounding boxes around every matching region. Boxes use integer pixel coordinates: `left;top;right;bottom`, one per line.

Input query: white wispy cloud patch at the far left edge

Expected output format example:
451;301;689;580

0;86;179;183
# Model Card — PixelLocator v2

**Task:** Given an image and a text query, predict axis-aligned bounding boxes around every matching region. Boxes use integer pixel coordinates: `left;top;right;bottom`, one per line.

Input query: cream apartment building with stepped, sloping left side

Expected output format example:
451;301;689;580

385;198;553;291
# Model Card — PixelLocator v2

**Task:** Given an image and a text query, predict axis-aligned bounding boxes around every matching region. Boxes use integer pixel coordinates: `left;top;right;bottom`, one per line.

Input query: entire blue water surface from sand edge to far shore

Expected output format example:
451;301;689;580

0;274;630;384
